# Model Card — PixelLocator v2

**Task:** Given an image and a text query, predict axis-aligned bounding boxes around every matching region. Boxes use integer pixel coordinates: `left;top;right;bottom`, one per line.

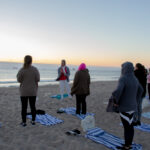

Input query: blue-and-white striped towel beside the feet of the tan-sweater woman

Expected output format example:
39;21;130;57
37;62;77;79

27;114;63;126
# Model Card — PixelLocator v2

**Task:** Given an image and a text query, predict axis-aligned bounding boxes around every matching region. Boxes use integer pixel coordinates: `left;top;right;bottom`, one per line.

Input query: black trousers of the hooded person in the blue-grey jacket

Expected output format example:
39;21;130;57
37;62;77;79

121;117;134;146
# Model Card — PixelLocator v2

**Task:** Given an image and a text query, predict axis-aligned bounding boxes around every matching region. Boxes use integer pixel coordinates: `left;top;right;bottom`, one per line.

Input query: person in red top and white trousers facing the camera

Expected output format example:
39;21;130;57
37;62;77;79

56;60;72;99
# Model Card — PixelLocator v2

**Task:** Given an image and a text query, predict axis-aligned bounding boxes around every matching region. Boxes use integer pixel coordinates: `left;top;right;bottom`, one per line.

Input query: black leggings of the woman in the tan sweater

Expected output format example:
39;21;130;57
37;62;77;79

21;96;36;123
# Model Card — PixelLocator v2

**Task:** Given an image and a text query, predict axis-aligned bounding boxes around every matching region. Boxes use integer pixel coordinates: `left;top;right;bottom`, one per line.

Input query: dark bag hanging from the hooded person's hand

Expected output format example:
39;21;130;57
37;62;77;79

106;96;119;113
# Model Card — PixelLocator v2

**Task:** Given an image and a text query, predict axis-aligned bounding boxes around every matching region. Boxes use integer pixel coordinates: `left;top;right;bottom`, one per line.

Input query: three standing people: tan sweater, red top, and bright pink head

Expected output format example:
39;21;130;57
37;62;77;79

17;55;90;126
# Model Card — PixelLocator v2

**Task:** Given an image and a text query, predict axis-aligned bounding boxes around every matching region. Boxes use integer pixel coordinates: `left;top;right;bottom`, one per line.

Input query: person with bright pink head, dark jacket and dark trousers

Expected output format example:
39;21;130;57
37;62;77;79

71;63;90;114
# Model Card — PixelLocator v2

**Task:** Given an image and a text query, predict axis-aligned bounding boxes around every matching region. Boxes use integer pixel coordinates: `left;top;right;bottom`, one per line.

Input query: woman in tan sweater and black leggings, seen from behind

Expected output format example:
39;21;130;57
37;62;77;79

17;55;40;126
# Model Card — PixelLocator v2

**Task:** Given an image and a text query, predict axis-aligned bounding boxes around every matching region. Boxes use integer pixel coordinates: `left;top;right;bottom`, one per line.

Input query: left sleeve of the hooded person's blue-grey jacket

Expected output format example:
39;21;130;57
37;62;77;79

112;77;125;104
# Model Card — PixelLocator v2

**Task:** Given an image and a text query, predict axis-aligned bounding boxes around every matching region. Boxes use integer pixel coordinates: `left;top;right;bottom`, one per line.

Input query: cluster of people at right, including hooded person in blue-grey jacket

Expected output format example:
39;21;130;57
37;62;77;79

112;62;150;150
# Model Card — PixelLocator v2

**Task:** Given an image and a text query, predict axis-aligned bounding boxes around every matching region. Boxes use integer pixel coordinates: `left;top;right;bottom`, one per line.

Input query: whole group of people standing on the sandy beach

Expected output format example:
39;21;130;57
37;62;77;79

17;55;150;150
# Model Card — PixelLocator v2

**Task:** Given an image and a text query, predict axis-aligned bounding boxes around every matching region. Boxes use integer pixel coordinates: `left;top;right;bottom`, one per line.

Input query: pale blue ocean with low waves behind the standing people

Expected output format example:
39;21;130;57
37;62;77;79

0;62;121;87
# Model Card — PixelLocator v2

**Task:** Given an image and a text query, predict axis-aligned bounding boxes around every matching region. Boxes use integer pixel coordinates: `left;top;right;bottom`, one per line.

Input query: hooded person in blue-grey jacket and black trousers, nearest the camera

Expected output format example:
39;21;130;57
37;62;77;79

112;62;143;150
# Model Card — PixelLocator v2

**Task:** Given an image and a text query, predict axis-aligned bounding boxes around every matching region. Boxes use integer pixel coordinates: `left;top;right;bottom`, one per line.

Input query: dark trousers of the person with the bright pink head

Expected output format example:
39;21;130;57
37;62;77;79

76;95;86;114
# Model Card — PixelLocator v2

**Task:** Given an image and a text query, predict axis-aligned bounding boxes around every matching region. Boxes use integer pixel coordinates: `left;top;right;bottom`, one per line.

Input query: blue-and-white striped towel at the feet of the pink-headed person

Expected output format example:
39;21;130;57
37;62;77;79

59;107;94;120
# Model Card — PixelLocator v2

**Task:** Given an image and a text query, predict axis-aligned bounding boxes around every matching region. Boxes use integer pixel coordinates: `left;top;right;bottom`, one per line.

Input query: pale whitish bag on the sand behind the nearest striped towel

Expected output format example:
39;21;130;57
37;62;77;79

81;116;95;132
